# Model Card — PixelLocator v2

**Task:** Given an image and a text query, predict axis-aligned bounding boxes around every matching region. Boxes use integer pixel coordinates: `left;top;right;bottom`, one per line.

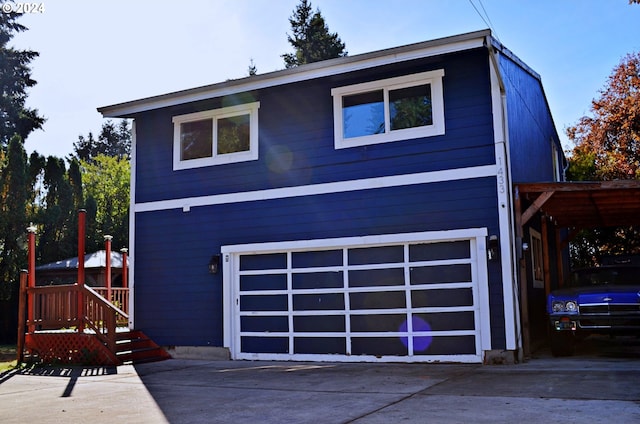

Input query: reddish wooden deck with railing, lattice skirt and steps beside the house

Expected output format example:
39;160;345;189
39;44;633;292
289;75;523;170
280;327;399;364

18;276;169;365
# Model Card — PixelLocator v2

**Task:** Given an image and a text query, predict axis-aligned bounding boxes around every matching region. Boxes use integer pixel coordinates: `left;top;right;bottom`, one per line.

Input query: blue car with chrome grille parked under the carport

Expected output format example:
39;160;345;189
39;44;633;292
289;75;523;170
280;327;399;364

547;266;640;356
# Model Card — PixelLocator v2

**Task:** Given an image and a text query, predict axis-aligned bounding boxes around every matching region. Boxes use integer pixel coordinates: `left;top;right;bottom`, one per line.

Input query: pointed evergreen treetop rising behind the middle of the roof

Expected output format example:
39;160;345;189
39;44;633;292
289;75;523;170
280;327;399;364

282;0;347;68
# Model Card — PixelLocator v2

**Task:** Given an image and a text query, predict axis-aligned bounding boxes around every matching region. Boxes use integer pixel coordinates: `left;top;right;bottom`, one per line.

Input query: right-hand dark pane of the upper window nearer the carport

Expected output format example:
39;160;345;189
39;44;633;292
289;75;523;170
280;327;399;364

389;84;433;130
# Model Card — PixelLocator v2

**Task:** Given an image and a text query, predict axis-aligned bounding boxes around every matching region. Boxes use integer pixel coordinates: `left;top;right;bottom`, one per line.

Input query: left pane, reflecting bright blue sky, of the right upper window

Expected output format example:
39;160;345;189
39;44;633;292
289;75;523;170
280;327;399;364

342;90;384;138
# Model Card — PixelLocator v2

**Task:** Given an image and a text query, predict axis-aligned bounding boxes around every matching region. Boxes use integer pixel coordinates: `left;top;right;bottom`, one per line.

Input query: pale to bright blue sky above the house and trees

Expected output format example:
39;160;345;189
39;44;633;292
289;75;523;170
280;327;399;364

8;0;640;157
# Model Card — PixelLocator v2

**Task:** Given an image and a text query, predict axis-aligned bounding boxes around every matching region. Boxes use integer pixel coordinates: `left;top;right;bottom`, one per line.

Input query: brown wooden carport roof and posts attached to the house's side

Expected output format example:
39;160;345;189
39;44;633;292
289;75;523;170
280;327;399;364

514;180;640;357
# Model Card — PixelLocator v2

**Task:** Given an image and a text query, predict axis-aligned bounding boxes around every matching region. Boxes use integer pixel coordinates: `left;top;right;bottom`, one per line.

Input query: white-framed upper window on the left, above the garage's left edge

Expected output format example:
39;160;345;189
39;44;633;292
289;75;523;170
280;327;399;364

173;102;260;170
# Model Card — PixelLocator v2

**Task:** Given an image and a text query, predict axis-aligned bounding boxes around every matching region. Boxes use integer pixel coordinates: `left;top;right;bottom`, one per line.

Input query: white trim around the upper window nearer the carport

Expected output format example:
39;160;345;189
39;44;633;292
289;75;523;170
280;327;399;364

331;69;445;149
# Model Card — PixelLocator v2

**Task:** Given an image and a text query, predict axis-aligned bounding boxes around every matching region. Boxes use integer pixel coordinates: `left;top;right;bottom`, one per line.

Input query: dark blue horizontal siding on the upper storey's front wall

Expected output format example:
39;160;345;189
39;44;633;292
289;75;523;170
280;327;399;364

136;49;495;203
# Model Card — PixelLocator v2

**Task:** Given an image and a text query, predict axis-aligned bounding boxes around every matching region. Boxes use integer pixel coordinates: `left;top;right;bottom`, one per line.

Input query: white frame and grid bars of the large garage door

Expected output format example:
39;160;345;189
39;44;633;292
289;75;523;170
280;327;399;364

221;228;491;362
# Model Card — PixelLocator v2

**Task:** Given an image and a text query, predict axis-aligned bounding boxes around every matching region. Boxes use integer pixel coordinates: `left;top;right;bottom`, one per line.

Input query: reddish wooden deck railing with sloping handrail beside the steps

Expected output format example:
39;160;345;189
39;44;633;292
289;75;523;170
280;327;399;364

26;284;129;354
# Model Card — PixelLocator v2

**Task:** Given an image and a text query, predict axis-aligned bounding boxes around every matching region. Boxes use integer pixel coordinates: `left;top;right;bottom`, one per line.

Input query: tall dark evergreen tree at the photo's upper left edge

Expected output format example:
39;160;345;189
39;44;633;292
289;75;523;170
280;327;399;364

0;13;45;147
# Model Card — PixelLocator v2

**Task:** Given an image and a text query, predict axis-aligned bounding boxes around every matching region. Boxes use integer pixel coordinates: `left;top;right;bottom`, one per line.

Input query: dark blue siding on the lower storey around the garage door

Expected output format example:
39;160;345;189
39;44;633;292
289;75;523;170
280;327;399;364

134;178;504;346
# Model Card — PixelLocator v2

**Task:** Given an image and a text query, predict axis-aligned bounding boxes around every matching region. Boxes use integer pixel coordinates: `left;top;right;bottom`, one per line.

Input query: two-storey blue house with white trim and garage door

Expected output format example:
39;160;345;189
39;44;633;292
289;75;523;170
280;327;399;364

99;30;564;362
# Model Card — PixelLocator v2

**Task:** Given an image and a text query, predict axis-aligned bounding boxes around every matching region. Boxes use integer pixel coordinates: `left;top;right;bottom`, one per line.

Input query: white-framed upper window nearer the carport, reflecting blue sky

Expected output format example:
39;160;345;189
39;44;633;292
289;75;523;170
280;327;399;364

331;69;444;149
